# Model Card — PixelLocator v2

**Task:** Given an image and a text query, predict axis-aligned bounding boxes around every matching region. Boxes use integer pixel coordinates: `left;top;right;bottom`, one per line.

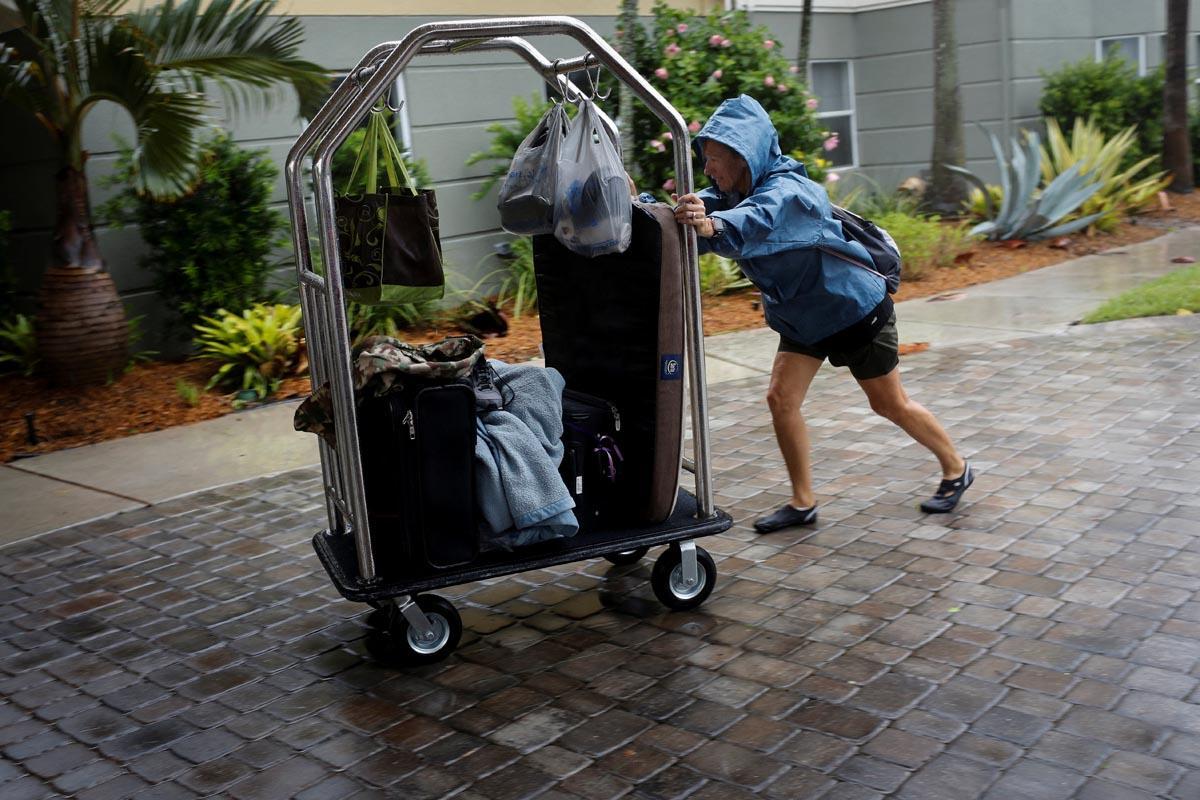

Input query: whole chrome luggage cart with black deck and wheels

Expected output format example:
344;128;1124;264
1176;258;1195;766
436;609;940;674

286;17;732;664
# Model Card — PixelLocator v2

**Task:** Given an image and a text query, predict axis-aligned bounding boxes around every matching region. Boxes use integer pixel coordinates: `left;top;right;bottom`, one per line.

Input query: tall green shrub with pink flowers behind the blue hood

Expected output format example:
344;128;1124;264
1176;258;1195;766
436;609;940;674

613;2;828;197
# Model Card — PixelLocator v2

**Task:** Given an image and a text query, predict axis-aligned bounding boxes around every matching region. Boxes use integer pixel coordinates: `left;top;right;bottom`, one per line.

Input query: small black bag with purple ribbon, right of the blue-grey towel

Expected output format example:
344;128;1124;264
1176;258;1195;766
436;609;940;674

558;389;626;531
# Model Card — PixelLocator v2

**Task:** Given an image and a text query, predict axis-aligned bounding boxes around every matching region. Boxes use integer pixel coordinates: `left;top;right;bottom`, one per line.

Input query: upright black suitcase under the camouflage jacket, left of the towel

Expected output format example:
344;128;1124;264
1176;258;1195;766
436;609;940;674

358;383;479;578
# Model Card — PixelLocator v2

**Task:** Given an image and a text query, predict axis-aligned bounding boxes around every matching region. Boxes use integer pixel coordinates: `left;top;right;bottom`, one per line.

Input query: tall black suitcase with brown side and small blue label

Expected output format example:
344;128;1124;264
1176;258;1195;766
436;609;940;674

533;203;684;527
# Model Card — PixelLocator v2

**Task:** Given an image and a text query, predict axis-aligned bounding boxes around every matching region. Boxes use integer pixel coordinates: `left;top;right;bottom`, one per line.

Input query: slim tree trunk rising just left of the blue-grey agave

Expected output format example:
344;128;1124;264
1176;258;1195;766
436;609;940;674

925;0;966;213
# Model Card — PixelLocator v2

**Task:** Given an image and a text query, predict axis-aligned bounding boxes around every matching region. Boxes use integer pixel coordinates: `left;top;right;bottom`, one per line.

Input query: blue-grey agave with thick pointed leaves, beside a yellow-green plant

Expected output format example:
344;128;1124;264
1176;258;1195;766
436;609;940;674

948;125;1100;241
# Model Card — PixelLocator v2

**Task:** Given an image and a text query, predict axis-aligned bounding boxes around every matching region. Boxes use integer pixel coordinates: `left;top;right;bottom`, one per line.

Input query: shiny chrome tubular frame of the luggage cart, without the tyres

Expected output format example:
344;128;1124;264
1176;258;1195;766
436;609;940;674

286;17;731;666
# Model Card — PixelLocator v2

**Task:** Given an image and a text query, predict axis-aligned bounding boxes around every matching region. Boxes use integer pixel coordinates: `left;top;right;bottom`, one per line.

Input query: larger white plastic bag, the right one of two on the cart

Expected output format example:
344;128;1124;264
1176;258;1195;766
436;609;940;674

554;100;634;258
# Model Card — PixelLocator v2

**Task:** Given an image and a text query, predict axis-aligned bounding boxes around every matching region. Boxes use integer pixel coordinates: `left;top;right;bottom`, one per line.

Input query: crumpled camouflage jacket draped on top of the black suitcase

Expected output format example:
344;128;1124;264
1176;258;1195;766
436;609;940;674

293;336;484;447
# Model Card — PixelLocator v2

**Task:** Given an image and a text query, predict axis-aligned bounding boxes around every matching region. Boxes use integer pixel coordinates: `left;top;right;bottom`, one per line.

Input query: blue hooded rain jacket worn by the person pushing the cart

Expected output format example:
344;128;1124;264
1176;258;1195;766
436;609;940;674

696;95;887;344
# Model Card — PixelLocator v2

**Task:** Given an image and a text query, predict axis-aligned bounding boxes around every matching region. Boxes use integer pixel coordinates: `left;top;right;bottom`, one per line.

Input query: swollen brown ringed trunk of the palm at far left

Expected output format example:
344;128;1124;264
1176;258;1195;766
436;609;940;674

36;164;128;386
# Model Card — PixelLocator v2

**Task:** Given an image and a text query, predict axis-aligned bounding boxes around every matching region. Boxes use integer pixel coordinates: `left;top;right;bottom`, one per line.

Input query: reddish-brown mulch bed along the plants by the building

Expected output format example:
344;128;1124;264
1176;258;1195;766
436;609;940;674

0;194;1200;463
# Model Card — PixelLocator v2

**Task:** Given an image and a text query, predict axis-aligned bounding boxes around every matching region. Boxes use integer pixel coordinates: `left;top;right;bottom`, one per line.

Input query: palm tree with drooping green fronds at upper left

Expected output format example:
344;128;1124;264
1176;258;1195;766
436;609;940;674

0;0;326;379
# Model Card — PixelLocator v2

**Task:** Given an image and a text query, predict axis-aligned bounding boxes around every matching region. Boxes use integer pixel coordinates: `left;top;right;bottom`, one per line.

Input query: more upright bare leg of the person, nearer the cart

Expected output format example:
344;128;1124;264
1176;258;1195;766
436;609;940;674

767;353;821;509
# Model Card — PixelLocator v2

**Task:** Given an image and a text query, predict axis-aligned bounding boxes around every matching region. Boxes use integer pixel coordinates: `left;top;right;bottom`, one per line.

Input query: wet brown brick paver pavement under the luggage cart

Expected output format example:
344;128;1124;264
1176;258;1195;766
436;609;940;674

0;318;1200;800
